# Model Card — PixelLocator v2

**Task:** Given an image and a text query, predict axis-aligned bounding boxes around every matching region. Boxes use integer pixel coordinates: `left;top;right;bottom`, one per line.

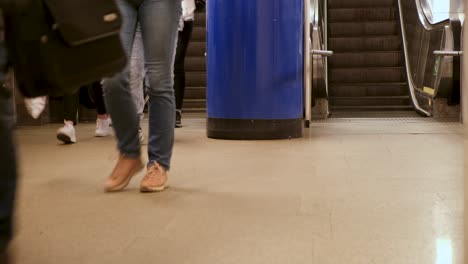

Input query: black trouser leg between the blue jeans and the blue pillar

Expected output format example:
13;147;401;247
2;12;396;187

174;21;193;110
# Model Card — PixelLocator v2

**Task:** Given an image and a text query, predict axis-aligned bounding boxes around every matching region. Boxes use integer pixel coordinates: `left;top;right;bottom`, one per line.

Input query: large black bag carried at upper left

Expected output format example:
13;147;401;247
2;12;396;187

3;0;127;97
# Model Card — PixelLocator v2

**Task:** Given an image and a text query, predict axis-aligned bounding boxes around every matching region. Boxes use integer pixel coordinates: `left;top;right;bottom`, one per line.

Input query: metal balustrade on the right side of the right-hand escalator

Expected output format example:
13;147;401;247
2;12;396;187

398;0;461;116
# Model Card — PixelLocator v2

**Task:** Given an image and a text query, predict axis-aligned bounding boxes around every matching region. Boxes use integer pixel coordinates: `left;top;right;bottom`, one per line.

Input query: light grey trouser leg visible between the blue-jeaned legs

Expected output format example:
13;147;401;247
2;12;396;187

130;24;145;142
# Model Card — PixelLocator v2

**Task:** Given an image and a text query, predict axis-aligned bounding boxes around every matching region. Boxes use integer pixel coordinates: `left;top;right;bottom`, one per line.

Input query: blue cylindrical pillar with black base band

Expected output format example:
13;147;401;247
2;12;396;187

207;0;304;139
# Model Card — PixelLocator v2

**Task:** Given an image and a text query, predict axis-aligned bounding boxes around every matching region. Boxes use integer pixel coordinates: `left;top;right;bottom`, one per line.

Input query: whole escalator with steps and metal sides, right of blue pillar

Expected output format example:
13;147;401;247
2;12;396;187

304;0;461;118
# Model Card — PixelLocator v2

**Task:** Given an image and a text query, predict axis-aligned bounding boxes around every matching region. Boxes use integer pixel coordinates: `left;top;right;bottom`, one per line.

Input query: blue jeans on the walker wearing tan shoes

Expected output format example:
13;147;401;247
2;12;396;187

104;0;182;170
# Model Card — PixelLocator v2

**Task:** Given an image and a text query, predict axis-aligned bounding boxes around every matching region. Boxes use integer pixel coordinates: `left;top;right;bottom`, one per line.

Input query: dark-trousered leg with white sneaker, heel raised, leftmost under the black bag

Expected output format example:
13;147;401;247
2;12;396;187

57;91;80;144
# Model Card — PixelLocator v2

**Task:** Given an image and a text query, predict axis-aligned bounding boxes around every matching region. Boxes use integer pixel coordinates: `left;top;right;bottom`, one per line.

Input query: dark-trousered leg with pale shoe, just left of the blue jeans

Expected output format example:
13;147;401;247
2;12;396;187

91;82;111;137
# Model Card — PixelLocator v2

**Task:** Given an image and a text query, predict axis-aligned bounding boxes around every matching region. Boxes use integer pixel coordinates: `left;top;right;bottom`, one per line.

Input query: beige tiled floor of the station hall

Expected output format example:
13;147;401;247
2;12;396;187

9;118;464;264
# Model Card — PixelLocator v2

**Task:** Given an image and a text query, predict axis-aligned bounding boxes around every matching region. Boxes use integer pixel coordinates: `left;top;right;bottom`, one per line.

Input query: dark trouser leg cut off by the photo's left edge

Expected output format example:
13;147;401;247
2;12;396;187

0;87;17;256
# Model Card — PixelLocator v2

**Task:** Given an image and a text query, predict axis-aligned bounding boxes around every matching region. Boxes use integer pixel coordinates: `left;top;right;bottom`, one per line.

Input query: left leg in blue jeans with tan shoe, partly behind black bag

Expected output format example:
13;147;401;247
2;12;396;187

103;0;142;192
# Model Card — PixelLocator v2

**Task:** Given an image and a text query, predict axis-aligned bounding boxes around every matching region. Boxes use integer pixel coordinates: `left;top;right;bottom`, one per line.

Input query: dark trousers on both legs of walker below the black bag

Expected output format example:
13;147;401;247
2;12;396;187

63;82;107;124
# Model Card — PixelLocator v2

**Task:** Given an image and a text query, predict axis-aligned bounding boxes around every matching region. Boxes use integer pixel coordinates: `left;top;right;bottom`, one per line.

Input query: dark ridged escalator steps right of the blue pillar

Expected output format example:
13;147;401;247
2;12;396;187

328;0;412;112
